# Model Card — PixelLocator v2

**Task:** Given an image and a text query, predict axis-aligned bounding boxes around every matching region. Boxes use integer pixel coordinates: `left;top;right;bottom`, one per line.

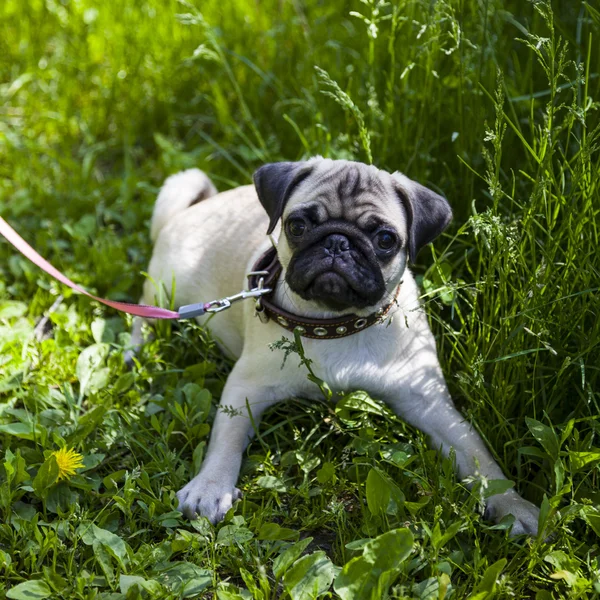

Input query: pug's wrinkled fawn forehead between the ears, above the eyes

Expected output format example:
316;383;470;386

284;161;406;232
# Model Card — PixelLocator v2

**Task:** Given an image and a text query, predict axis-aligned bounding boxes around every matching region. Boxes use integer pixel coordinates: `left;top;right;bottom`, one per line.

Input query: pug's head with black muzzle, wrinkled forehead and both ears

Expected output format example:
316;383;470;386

254;157;452;311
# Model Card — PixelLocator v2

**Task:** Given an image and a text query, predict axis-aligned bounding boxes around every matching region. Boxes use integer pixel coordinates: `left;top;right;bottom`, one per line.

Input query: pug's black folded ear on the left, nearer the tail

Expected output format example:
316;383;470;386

252;162;313;234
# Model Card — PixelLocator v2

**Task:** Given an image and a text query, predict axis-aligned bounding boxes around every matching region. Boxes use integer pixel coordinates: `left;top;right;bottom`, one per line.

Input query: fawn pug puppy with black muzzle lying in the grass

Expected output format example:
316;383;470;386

134;157;539;535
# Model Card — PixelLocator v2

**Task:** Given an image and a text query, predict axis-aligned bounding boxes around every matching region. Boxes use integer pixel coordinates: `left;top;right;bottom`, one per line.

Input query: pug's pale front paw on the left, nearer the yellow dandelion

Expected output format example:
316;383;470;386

177;474;242;525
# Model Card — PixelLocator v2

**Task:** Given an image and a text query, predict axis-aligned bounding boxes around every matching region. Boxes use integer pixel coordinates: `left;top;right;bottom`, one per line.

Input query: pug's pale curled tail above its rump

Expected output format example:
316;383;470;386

150;169;218;242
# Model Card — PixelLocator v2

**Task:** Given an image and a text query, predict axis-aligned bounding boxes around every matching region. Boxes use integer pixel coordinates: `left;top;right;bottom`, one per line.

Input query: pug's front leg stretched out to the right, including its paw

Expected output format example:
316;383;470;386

388;353;539;535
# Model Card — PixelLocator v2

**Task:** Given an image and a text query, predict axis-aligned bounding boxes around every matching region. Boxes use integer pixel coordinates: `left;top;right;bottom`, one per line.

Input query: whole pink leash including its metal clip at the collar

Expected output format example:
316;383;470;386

0;217;272;319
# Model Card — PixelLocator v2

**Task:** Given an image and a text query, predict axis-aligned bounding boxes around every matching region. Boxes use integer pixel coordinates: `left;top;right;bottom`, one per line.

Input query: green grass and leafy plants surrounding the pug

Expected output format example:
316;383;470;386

0;0;600;600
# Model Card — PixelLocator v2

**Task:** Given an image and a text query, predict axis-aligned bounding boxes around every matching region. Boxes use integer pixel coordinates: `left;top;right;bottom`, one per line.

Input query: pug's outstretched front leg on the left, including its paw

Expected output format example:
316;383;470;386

177;363;279;524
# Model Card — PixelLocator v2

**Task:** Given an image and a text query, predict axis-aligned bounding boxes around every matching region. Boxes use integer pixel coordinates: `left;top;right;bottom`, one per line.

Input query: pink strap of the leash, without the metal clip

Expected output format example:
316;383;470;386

0;217;206;319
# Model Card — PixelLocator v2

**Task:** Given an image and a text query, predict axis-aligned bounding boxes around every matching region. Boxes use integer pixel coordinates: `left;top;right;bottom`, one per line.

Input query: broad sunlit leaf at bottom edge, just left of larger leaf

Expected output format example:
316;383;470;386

283;551;335;600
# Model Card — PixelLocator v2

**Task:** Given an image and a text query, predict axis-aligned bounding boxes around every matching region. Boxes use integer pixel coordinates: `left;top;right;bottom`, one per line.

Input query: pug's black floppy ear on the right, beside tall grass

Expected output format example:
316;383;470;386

392;173;452;264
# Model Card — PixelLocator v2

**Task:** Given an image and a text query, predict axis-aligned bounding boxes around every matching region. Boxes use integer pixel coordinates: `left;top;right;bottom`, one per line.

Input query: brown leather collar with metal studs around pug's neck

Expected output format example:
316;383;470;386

248;248;400;340
